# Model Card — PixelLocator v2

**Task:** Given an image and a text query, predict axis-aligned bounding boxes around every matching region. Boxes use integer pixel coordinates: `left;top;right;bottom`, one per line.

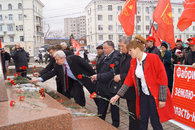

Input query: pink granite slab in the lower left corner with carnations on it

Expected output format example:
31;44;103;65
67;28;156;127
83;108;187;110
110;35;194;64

0;89;72;130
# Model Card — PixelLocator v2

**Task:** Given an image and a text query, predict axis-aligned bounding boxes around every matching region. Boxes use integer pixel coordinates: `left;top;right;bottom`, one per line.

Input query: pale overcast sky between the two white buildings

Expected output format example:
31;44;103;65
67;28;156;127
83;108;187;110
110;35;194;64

41;0;91;31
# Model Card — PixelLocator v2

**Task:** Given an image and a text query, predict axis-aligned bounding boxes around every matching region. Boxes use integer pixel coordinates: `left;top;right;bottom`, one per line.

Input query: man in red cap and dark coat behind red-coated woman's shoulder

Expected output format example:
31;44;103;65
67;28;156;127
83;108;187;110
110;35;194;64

145;36;162;60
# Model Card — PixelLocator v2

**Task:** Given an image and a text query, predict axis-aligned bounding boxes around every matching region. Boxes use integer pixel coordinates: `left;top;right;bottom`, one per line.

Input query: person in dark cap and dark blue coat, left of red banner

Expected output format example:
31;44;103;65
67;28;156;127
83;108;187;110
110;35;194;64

161;41;173;93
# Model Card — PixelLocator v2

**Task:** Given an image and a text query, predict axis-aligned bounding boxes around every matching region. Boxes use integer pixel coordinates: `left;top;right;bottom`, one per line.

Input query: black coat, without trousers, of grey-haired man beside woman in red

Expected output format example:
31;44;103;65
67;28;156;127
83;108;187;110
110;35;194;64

120;54;136;100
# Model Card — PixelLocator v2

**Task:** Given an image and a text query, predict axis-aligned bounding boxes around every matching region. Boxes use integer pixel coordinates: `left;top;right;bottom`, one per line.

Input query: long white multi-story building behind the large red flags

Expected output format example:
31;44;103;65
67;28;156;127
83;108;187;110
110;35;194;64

85;0;195;52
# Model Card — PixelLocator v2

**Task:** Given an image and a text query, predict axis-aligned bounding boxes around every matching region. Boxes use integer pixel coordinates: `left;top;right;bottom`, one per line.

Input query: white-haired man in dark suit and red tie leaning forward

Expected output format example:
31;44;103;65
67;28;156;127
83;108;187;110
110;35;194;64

32;50;95;106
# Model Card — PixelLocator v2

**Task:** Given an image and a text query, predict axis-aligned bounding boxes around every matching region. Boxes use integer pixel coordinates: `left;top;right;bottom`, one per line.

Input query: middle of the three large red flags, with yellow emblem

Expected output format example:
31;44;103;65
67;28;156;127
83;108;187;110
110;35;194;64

153;0;175;49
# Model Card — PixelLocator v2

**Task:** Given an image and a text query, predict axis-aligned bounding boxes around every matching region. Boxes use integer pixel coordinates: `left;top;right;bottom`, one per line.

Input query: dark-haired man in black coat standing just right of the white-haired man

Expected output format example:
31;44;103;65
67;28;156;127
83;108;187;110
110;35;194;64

91;41;120;127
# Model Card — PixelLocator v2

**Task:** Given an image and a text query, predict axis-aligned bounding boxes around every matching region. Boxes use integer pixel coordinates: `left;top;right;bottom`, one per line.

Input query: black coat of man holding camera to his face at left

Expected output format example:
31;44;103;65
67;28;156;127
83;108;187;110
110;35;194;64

11;48;29;71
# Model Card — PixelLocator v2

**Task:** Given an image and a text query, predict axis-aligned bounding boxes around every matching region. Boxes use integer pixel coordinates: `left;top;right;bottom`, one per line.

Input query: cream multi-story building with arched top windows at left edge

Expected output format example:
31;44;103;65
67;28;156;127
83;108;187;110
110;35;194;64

0;0;44;56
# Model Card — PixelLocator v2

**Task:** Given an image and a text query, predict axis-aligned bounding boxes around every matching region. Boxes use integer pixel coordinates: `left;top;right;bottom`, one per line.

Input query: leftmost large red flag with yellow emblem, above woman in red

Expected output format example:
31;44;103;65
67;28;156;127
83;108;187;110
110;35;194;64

118;0;137;36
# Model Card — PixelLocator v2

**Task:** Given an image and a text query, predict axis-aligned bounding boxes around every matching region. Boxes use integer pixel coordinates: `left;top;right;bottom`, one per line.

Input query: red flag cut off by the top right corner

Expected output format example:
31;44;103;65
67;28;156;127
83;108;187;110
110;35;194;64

177;0;195;32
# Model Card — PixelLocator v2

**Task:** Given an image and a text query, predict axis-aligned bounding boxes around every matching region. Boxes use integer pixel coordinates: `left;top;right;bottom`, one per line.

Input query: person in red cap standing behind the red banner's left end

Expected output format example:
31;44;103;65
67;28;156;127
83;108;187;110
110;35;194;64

171;39;184;64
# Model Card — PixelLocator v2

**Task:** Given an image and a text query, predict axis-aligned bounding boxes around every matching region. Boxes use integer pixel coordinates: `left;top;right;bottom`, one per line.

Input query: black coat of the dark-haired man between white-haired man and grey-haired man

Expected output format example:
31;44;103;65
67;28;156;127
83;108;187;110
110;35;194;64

96;50;121;97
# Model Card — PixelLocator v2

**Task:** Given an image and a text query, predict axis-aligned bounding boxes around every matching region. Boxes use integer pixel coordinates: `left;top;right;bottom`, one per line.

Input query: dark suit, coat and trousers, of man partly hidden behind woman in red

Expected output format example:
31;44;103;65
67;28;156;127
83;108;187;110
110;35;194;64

120;54;138;130
